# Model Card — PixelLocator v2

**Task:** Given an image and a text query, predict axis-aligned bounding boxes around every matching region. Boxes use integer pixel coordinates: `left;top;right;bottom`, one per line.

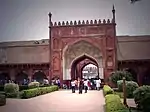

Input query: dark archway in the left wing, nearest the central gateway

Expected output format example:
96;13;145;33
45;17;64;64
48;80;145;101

32;71;47;83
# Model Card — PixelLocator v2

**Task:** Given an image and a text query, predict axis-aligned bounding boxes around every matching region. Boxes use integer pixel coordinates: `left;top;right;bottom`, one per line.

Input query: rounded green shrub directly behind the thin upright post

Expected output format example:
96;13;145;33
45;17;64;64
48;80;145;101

117;80;139;98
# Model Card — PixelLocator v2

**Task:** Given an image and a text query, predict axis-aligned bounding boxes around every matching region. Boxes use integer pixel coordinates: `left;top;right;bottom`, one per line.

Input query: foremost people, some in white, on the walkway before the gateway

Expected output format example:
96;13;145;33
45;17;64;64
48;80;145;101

71;78;101;94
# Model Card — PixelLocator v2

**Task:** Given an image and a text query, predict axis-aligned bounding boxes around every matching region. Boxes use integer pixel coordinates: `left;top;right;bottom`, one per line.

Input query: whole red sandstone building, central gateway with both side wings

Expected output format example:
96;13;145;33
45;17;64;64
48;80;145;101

0;10;150;86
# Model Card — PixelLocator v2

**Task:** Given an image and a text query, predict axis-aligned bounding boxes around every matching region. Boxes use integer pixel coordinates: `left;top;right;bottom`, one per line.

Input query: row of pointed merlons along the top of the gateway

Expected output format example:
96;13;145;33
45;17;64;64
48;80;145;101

51;19;114;26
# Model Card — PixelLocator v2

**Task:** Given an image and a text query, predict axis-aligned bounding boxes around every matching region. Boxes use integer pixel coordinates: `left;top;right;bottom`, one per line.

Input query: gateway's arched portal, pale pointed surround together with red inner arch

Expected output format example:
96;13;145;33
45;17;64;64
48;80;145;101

63;40;103;80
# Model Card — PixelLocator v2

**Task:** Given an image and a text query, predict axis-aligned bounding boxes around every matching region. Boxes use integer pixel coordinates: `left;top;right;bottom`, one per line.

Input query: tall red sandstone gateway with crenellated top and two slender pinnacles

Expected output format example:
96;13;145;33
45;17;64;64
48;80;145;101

49;7;117;84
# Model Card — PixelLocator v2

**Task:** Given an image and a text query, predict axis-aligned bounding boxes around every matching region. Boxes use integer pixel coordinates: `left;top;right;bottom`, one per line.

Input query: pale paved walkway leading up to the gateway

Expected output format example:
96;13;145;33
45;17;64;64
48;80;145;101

0;90;105;112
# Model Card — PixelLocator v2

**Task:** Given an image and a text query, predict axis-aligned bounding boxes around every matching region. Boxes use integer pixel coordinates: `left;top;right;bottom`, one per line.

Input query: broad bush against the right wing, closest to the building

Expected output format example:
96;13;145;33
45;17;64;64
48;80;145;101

110;71;132;84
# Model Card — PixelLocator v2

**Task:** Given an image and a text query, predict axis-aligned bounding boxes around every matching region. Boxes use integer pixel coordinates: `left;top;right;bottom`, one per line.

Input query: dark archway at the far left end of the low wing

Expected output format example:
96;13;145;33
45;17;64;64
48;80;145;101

0;72;10;85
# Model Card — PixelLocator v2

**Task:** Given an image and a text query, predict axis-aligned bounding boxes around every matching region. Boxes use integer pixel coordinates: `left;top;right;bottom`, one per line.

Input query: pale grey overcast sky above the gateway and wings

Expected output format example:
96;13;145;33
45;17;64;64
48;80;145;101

0;0;150;41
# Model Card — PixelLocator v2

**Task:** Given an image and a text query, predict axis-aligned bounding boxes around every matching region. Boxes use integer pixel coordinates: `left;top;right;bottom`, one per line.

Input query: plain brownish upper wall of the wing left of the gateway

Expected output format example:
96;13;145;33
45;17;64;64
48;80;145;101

0;41;49;64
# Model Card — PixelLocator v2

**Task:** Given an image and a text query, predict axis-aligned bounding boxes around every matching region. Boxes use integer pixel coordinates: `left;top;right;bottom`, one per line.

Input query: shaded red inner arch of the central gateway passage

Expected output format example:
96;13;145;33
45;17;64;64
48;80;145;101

71;55;98;79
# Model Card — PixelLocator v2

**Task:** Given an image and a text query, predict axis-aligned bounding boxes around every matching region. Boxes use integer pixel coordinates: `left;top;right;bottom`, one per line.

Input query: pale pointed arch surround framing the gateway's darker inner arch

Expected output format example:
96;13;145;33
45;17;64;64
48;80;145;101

63;40;103;80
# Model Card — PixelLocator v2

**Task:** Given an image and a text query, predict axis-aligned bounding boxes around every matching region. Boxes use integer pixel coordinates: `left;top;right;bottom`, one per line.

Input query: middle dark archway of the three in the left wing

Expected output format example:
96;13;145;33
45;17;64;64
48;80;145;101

15;71;28;85
